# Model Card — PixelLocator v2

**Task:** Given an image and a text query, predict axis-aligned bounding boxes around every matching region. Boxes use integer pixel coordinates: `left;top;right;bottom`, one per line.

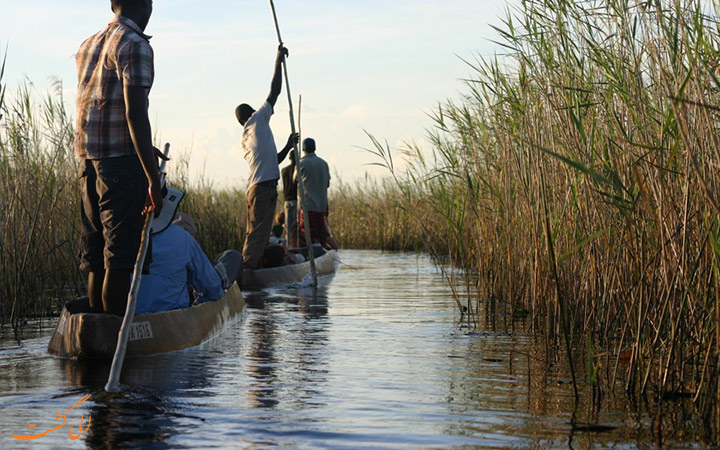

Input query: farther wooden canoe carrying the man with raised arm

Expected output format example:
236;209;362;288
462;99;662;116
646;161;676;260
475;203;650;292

242;246;340;290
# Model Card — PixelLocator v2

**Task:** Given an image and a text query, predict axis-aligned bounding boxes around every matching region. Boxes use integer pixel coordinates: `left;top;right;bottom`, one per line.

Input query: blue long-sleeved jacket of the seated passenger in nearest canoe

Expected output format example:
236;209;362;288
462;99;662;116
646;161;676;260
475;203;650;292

135;225;223;314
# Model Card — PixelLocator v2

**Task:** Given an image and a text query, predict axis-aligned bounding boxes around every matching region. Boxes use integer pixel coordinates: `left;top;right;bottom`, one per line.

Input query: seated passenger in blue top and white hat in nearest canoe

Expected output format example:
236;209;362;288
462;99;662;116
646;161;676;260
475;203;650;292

135;213;242;314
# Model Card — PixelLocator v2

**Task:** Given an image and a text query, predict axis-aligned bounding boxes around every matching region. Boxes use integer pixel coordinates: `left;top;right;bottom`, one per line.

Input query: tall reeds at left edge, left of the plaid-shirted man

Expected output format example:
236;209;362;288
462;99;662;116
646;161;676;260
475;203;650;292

0;76;81;329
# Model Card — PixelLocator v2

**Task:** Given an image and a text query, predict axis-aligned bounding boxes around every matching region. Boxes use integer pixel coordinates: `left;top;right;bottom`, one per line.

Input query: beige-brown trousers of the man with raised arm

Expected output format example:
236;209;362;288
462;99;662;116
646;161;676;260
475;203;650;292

243;180;277;269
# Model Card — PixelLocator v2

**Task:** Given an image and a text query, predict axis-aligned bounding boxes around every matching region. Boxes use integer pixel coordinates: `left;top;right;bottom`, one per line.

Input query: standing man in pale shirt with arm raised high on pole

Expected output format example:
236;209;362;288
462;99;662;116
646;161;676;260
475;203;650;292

235;45;298;269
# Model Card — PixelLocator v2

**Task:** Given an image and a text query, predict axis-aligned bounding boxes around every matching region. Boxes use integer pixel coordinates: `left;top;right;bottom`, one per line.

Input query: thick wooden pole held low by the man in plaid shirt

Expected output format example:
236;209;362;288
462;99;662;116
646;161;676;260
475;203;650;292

105;144;170;392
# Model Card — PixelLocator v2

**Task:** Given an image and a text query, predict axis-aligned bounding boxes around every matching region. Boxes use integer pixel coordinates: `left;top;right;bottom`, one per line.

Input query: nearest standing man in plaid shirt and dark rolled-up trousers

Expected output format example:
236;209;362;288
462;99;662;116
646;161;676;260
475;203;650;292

75;0;162;316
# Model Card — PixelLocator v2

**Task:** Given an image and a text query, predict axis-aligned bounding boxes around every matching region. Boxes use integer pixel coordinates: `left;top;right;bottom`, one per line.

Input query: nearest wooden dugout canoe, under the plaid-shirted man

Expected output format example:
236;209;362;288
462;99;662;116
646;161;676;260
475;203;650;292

48;283;245;359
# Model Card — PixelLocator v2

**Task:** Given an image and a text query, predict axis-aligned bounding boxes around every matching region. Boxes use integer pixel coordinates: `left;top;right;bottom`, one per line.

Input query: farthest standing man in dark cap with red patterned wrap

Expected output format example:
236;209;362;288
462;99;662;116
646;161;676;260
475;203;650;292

298;138;338;250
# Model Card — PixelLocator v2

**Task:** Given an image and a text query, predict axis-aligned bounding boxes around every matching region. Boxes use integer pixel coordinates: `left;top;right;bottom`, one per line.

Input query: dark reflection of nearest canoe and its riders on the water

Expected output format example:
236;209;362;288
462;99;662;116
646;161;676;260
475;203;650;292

57;344;213;449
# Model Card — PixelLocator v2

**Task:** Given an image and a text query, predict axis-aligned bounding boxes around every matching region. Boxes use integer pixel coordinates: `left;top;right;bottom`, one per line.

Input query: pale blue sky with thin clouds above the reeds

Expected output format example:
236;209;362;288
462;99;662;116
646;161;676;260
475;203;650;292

0;0;507;187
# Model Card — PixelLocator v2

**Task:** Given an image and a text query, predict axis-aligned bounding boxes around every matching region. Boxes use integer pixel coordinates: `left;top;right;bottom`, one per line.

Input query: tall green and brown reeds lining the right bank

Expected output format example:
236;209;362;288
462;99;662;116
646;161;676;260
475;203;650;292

371;0;720;442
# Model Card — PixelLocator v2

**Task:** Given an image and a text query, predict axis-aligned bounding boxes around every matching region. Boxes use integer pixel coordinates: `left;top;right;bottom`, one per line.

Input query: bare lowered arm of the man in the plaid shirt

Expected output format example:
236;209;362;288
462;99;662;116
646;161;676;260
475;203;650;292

124;86;162;216
